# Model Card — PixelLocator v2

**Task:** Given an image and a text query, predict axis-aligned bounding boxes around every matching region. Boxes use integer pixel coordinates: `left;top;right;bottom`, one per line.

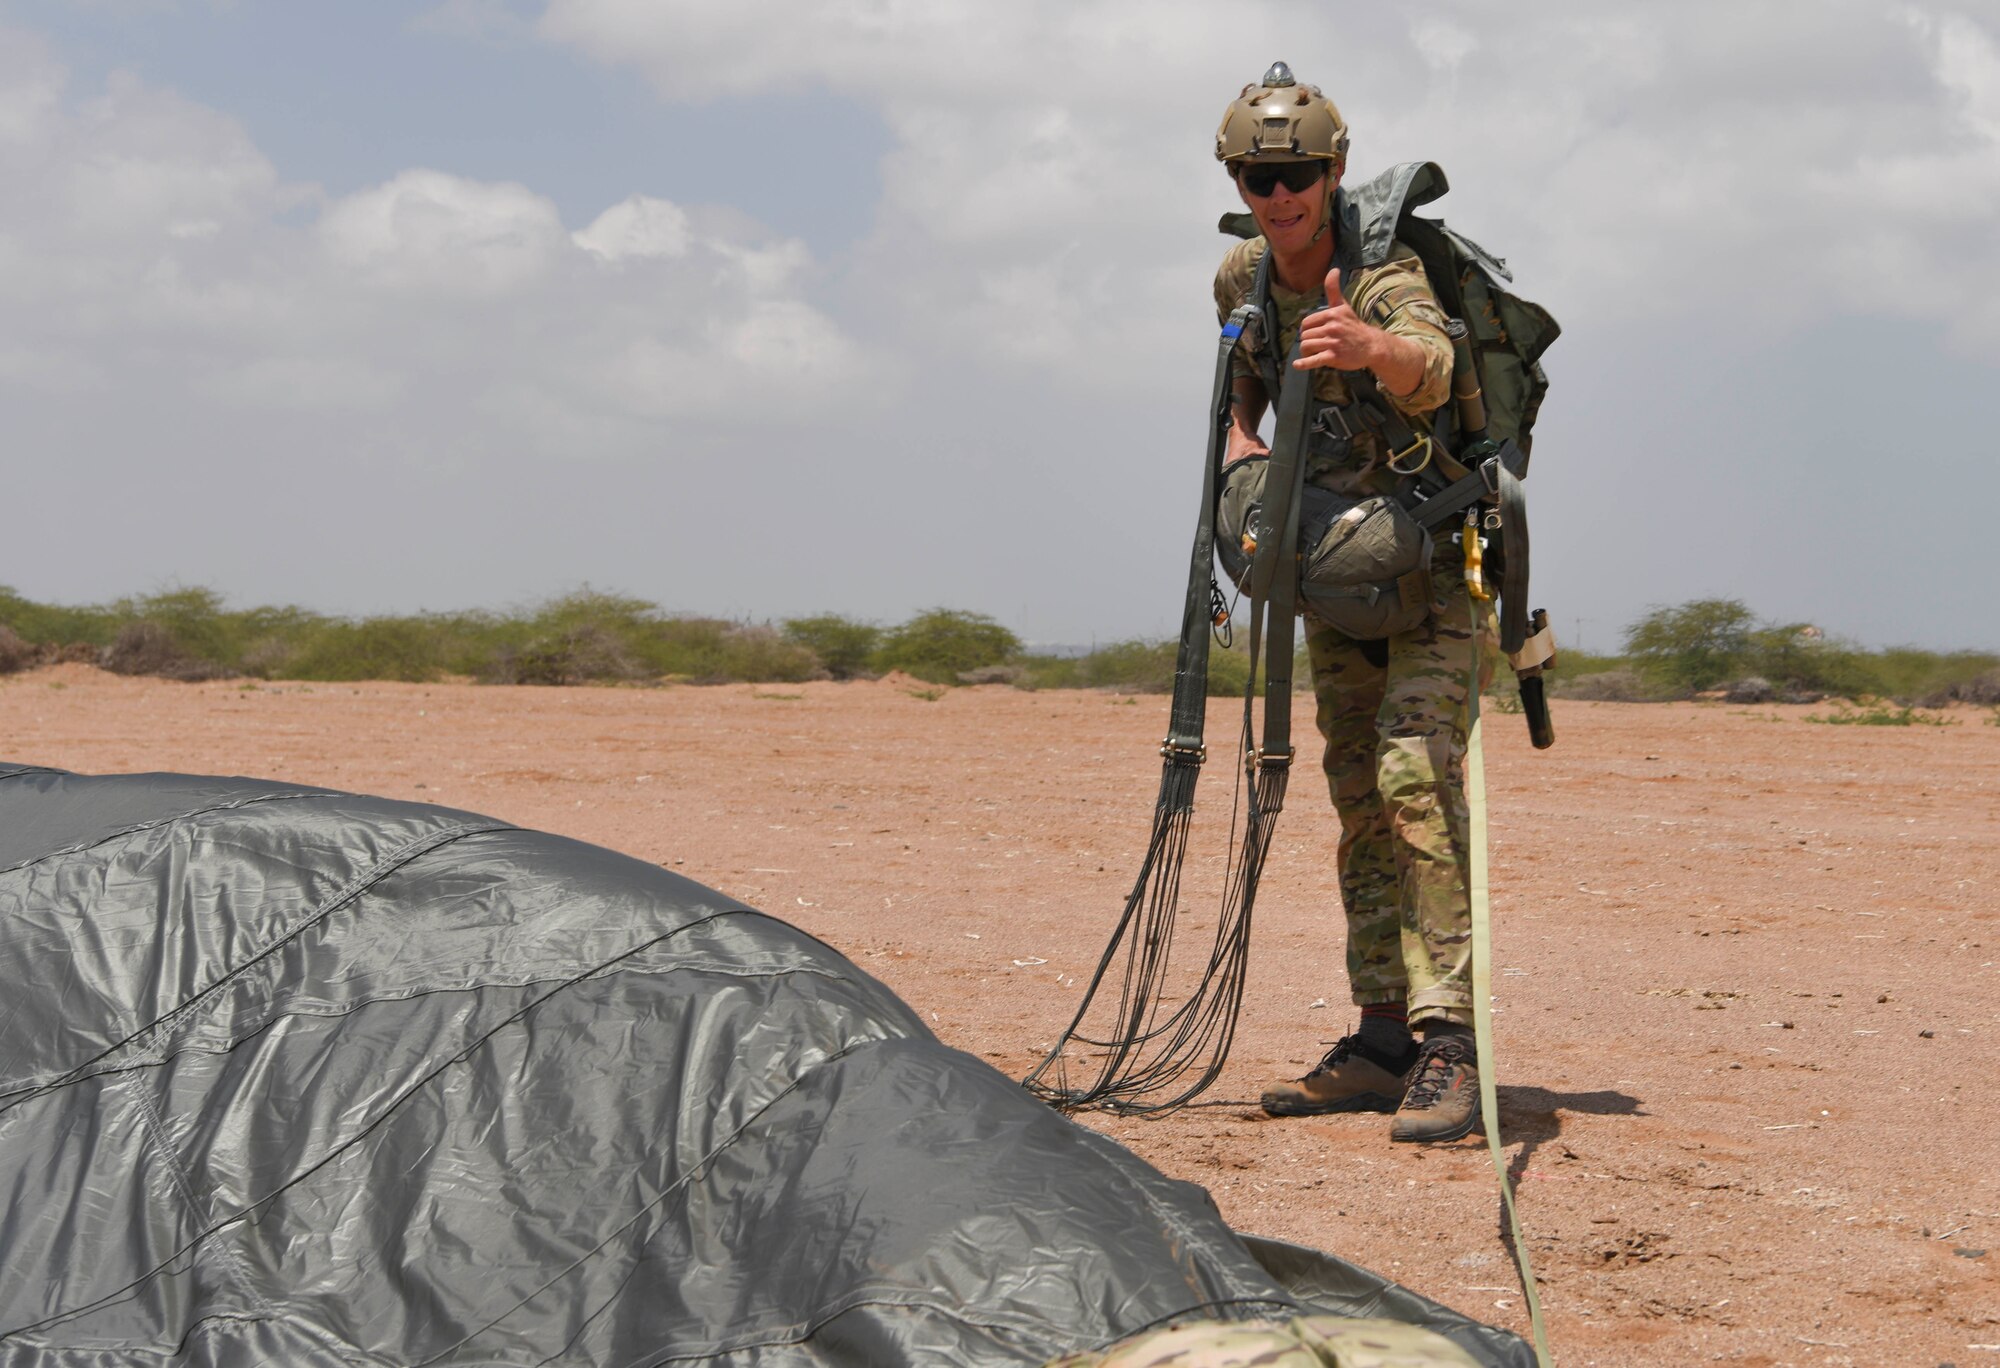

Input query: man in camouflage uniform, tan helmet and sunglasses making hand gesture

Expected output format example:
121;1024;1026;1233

1216;62;1492;1142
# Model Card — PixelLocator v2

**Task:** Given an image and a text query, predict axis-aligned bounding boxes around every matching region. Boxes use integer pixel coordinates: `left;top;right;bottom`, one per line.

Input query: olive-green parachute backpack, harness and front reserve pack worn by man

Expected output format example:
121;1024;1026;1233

1216;162;1560;652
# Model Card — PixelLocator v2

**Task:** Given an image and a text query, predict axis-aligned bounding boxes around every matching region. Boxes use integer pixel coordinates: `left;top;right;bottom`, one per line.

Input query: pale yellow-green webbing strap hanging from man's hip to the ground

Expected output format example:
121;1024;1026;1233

1464;536;1552;1368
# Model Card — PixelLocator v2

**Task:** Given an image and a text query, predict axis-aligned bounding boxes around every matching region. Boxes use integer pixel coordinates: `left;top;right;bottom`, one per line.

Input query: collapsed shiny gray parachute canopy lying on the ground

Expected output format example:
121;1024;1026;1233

0;764;1532;1368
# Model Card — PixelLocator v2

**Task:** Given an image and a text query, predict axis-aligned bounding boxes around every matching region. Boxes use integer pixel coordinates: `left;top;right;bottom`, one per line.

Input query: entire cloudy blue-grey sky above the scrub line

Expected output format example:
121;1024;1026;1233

0;0;2000;648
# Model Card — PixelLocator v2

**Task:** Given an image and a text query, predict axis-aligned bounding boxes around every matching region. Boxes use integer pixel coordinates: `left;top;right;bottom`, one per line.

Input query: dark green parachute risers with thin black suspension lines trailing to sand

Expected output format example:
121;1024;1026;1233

1022;304;1312;1114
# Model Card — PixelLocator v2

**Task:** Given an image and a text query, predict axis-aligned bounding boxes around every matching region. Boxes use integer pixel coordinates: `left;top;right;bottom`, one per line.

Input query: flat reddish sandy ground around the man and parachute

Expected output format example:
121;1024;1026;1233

0;664;2000;1368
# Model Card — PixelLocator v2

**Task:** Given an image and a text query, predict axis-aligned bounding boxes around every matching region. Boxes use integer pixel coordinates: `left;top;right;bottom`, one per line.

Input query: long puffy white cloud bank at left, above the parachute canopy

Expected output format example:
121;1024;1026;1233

0;34;870;448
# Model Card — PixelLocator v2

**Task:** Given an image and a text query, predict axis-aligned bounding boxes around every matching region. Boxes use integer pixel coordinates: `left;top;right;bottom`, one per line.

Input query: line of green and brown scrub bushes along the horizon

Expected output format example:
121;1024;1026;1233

0;586;2000;704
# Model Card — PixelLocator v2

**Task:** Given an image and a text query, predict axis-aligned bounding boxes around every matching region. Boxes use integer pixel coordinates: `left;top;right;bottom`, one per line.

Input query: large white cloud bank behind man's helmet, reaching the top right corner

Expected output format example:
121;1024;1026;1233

540;0;2000;352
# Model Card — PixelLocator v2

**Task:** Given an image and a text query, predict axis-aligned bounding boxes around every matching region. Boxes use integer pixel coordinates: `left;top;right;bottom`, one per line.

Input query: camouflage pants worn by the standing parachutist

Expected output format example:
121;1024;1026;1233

1306;572;1496;1026
